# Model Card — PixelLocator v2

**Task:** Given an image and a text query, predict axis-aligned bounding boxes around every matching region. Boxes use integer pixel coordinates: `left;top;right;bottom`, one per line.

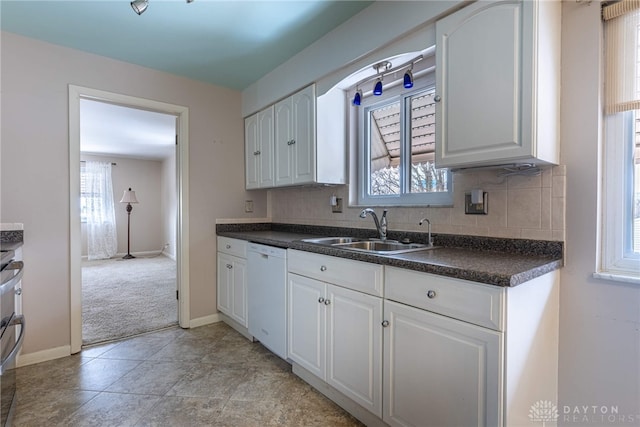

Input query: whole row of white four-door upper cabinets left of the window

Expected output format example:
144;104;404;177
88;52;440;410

245;85;347;189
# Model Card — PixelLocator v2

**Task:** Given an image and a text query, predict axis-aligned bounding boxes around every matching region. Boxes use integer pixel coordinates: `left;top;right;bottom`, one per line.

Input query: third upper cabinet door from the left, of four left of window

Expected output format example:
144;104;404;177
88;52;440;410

275;97;294;186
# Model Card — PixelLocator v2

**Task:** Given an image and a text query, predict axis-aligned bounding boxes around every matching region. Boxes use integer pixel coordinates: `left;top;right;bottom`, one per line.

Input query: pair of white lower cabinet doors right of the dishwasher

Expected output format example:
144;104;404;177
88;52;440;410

288;273;382;417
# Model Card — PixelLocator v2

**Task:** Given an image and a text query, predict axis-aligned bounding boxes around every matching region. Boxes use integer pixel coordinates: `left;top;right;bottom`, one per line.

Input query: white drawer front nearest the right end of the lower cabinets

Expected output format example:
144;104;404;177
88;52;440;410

385;267;505;331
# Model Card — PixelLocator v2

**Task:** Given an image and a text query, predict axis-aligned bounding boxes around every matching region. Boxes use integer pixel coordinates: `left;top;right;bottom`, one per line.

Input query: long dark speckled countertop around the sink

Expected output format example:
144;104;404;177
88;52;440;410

216;223;563;286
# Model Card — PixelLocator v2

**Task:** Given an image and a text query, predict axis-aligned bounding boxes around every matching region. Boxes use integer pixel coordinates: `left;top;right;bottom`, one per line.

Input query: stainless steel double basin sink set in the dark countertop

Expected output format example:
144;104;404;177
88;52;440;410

302;237;437;255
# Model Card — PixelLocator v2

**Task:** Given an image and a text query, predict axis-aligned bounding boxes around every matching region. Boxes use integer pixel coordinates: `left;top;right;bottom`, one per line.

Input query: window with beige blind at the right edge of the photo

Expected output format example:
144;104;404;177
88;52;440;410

596;0;640;283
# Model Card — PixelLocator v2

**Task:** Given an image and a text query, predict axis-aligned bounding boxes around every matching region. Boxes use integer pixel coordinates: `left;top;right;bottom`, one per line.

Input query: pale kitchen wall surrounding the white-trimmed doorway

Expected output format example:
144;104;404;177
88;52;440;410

0;32;266;355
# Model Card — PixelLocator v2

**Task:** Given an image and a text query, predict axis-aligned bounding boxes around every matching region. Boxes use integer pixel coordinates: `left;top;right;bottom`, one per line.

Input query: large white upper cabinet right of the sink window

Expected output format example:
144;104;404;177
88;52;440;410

436;0;560;168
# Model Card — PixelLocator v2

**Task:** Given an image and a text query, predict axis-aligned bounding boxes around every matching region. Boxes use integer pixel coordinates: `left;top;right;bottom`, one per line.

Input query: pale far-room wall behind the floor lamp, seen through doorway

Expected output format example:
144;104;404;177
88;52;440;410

80;154;166;256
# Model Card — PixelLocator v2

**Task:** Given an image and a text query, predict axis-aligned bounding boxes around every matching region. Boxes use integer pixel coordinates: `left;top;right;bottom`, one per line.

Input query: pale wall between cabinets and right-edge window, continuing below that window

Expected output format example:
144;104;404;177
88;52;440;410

559;1;640;425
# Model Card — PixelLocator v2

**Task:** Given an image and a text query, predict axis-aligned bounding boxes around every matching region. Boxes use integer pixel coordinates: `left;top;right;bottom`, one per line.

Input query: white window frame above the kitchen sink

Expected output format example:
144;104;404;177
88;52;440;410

352;69;453;207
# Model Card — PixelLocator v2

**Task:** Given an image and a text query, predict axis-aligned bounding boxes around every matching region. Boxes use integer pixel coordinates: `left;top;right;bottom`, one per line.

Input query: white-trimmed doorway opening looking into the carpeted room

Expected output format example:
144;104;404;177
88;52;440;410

69;85;189;353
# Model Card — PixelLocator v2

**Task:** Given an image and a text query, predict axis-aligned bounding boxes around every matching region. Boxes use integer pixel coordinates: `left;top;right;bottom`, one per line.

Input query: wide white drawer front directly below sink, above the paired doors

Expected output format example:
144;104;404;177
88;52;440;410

287;249;383;297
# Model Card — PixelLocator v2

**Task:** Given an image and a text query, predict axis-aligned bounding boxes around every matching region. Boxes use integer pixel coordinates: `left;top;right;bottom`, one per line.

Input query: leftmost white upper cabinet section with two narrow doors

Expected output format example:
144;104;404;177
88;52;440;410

244;106;274;190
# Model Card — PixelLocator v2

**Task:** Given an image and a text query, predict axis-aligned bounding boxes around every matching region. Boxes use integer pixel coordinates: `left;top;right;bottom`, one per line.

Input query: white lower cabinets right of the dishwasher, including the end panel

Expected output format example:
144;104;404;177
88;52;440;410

288;250;559;427
